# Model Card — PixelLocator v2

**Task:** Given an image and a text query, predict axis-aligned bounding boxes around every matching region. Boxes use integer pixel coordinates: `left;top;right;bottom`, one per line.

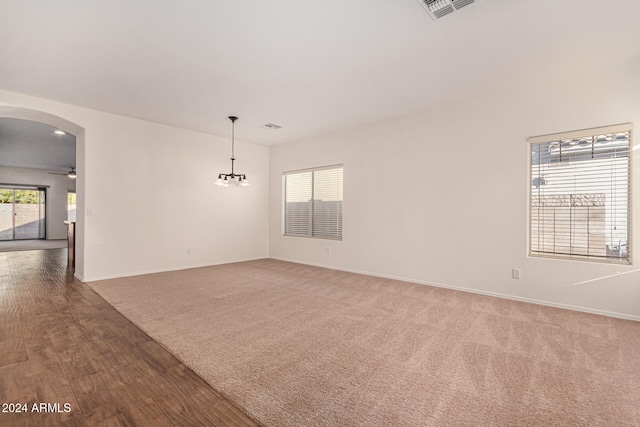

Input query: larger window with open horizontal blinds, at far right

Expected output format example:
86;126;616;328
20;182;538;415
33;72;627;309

529;124;631;263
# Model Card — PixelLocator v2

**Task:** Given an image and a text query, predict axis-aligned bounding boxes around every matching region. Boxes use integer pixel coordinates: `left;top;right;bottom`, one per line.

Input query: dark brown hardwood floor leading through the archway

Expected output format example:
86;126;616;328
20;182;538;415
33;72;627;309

0;249;257;427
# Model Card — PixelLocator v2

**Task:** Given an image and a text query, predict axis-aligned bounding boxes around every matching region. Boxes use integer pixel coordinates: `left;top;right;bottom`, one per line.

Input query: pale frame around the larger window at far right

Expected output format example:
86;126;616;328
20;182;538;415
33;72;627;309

527;123;635;265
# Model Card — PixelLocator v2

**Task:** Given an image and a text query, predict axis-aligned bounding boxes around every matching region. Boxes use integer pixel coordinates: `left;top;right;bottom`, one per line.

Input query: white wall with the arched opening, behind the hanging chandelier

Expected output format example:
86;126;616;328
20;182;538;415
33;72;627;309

0;91;269;281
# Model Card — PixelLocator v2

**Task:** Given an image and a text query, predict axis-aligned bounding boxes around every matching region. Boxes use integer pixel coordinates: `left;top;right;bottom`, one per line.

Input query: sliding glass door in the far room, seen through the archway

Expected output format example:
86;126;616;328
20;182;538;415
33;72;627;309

0;188;46;240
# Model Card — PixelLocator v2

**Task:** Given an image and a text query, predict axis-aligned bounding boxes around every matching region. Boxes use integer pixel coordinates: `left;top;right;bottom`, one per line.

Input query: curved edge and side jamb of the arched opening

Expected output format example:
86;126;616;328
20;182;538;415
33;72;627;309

0;105;86;281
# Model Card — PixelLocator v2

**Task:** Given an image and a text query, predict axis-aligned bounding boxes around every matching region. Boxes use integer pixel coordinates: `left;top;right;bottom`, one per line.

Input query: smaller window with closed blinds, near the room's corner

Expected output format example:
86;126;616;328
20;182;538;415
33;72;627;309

282;165;342;240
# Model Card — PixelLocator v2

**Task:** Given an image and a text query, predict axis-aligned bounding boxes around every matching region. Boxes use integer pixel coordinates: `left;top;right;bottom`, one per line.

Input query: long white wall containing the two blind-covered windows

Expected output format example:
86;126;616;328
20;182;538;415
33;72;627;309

270;61;640;320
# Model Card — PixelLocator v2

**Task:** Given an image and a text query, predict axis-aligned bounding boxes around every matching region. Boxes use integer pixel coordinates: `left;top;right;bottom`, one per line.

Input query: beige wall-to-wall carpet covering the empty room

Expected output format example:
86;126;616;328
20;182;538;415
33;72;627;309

90;260;640;426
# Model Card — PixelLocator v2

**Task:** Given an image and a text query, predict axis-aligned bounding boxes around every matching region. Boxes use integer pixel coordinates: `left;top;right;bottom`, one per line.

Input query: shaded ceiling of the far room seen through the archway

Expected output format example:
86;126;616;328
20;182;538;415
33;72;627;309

0;118;76;172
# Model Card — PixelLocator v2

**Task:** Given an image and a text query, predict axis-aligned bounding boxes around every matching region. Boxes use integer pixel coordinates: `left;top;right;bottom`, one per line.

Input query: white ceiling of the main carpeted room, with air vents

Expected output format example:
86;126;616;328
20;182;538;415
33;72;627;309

0;0;640;145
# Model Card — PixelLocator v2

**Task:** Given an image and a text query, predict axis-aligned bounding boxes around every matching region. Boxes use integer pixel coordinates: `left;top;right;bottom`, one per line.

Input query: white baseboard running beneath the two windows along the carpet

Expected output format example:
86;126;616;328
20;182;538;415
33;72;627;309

270;257;640;322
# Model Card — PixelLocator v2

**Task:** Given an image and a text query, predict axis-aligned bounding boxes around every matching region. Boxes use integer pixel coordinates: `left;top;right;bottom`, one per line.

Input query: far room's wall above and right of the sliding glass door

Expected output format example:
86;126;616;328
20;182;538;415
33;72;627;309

0;166;76;239
